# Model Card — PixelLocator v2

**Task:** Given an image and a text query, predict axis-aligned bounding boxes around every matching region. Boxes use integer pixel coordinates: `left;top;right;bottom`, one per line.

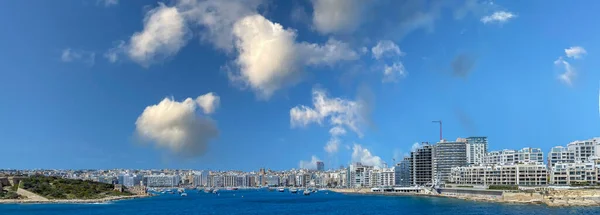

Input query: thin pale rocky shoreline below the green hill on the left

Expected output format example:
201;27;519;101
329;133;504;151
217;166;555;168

0;195;151;204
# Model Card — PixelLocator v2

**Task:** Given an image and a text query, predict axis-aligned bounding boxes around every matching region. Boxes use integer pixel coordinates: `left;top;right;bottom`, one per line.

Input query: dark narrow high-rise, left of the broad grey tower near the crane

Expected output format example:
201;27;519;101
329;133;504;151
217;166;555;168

409;142;433;185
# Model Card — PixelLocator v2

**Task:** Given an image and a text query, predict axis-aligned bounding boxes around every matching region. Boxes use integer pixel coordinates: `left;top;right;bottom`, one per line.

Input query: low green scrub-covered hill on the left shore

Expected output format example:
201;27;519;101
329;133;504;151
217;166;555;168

19;176;132;199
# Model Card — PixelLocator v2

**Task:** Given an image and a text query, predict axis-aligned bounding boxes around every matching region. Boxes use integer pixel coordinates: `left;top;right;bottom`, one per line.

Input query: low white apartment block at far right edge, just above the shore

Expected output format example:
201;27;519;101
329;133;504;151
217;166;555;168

550;162;598;185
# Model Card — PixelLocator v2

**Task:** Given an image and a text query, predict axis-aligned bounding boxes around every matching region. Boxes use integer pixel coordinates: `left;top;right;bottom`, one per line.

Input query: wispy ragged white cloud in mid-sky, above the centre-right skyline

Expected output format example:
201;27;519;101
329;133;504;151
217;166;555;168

290;88;365;136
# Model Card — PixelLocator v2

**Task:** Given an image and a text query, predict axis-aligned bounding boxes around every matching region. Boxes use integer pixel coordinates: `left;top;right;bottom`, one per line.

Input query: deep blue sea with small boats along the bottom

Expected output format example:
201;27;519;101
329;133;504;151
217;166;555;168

0;189;600;215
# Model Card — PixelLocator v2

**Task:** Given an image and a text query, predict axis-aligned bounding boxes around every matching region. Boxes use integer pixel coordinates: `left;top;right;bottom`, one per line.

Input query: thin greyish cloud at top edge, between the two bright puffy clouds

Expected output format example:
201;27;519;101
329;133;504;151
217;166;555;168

177;0;263;53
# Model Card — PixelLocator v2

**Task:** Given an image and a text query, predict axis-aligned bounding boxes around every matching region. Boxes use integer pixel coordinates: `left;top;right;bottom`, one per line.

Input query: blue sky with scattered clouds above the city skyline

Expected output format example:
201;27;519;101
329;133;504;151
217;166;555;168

0;0;600;170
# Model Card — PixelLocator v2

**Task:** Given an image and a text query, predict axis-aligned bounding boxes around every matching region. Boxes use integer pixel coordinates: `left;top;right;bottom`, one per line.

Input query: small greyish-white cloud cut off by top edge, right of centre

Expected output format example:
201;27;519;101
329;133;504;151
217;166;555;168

312;0;366;34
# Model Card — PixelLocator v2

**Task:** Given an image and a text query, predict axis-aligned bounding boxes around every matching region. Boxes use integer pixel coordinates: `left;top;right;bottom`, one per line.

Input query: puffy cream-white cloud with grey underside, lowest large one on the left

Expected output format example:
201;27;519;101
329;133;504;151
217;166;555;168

135;92;219;157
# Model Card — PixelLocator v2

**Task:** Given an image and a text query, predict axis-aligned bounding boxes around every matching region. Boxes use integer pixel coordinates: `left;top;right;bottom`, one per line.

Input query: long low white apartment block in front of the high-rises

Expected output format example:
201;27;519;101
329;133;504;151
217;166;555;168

450;162;548;186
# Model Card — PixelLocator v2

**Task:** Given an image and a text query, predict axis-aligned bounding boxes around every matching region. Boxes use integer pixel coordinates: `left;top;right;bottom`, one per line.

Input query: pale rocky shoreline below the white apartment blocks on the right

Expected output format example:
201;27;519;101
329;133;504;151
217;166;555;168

329;188;600;207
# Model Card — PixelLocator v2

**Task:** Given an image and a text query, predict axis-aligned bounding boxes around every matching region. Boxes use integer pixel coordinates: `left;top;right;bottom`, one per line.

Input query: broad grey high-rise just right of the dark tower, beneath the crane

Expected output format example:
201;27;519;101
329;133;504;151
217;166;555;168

432;139;468;183
